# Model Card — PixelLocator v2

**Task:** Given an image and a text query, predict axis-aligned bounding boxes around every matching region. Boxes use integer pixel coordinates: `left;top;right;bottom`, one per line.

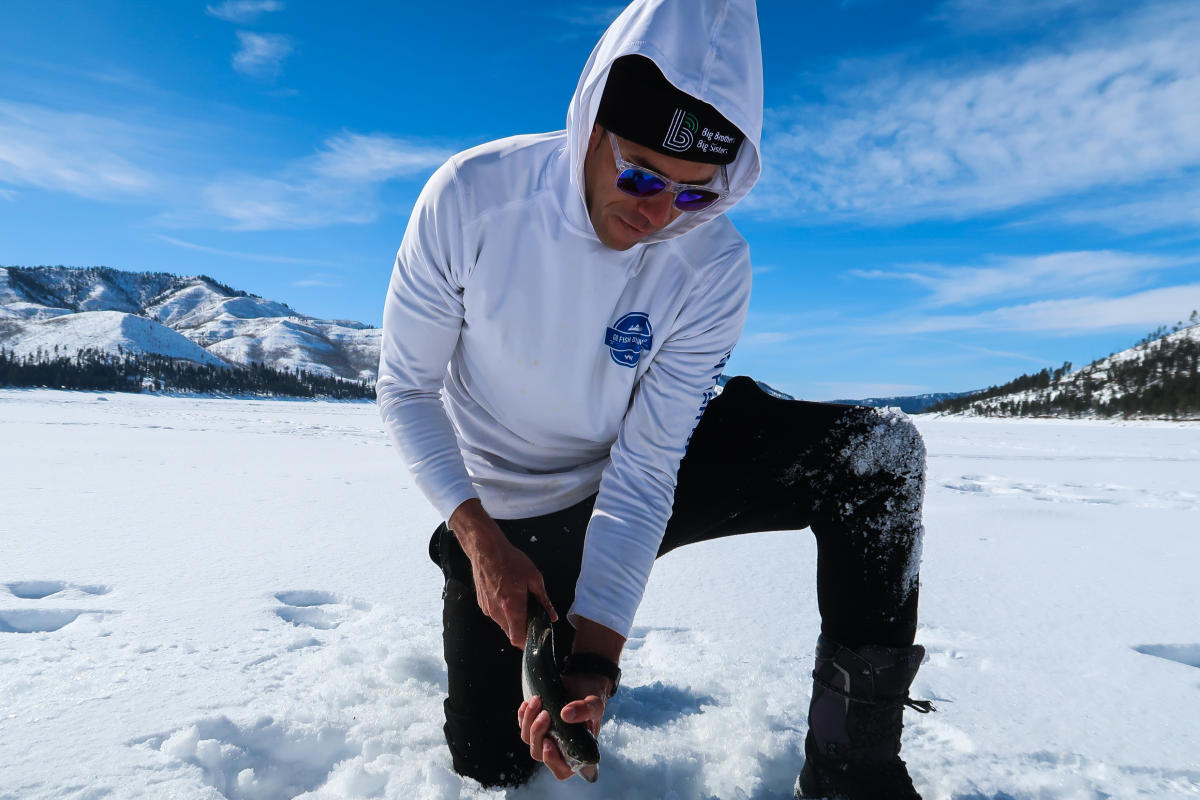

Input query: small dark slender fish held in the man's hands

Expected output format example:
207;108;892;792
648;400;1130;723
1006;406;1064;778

521;595;600;783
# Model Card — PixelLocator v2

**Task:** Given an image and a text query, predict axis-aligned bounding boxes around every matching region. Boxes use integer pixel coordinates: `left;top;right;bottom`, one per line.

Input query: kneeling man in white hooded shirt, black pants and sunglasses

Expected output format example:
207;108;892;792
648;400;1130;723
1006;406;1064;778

377;0;924;800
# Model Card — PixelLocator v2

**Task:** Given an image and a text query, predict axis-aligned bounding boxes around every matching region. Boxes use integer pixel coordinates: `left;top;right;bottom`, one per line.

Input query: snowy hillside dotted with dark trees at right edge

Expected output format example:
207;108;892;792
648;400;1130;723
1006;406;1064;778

930;312;1200;419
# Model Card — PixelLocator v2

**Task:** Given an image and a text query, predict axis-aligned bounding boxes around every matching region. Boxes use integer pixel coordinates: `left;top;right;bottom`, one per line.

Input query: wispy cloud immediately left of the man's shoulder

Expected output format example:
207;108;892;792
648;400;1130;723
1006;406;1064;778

204;132;451;230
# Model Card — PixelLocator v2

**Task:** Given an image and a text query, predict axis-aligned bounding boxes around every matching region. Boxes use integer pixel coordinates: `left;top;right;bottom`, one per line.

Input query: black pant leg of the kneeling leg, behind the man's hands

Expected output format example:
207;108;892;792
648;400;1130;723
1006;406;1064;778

430;498;594;787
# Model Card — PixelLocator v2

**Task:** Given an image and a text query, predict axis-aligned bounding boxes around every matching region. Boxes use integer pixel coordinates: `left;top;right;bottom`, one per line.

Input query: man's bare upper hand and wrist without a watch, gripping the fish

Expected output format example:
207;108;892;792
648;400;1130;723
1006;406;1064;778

448;499;558;648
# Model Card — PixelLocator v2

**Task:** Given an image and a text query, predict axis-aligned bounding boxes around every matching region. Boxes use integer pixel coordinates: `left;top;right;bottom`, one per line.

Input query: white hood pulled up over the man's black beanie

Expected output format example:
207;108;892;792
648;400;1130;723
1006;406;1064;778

566;0;762;243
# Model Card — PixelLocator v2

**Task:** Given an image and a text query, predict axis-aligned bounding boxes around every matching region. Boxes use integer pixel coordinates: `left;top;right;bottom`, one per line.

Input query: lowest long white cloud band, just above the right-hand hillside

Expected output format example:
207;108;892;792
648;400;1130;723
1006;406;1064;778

875;283;1200;336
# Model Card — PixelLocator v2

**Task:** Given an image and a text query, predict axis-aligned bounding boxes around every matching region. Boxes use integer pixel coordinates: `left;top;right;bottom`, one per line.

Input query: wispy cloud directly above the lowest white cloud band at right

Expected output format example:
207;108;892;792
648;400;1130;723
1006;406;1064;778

852;251;1200;307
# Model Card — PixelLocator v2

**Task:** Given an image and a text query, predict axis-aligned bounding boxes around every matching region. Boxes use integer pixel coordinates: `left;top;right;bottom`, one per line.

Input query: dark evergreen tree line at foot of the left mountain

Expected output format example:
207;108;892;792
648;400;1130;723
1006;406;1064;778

0;348;374;399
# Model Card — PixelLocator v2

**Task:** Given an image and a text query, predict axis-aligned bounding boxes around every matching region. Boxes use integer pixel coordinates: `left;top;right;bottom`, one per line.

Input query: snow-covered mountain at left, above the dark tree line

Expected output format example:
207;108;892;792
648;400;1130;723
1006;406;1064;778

0;266;380;383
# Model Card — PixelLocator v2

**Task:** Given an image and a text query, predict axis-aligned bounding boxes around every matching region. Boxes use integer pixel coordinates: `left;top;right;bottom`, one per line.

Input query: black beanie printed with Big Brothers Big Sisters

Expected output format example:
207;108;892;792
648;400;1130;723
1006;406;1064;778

596;55;745;164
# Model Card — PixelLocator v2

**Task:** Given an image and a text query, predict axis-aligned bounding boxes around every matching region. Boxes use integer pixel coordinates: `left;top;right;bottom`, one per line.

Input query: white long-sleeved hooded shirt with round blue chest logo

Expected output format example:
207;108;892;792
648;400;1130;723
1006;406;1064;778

376;0;762;637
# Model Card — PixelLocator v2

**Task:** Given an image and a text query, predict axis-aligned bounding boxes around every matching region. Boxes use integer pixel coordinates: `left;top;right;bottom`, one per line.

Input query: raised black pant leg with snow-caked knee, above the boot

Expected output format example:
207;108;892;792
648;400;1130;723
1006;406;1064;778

659;378;925;646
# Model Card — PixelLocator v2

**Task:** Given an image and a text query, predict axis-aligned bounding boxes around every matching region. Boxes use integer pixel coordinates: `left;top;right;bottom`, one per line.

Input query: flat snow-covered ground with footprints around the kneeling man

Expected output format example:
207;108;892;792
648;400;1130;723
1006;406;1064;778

0;390;1200;800
